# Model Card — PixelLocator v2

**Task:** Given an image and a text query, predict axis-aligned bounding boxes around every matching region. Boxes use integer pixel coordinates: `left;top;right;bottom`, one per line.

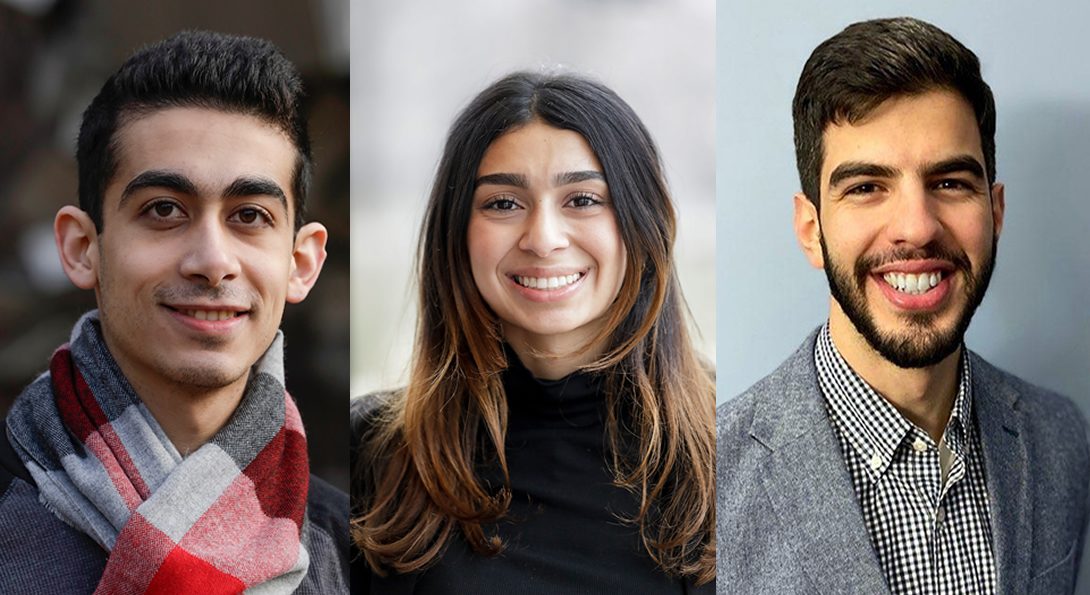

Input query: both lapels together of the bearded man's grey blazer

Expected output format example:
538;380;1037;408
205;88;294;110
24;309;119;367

750;330;1033;593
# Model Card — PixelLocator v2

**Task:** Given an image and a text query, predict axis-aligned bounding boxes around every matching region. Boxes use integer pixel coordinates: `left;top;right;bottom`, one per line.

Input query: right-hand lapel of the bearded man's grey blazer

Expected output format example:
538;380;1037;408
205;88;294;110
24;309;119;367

970;352;1033;593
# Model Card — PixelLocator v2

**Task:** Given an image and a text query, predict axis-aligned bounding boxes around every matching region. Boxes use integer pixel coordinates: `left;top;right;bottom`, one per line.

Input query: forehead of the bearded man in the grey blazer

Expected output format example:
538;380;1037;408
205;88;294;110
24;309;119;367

821;89;984;178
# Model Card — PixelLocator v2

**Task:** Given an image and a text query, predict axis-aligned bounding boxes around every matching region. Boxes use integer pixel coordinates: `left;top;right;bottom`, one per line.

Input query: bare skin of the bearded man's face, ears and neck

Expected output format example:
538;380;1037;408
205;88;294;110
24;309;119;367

795;90;1005;440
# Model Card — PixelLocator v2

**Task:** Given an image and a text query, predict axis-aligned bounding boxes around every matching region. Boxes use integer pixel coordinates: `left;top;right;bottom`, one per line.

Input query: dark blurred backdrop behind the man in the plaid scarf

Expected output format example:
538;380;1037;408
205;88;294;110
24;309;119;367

0;0;349;489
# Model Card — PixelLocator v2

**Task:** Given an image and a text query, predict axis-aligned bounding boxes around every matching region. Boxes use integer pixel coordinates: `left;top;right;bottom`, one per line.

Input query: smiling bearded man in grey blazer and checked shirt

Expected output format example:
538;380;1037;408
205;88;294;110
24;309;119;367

716;19;1090;594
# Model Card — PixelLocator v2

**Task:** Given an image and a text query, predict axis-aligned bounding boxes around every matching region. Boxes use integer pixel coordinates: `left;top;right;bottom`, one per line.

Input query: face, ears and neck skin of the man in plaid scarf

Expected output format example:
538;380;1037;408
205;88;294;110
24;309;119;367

53;108;326;456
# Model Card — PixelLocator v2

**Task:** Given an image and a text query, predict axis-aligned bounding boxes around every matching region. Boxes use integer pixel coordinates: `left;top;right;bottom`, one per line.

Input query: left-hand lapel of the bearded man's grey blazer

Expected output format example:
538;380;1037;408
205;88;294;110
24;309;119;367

750;333;889;593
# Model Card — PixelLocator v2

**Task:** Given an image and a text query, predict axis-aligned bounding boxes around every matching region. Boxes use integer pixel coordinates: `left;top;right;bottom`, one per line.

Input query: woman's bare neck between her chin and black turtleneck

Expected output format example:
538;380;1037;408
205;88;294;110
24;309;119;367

504;327;603;380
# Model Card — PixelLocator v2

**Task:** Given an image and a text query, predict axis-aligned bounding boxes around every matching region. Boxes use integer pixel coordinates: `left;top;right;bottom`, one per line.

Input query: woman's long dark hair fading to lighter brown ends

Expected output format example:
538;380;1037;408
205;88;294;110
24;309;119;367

352;72;715;583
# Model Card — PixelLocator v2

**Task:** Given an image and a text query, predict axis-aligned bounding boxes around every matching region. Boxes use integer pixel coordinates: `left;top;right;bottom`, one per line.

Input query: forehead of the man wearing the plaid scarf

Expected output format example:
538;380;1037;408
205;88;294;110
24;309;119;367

105;107;296;208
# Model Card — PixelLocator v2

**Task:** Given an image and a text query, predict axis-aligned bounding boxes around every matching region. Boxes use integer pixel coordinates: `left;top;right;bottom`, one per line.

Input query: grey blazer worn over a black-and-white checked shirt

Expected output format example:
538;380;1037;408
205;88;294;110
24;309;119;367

716;332;1090;595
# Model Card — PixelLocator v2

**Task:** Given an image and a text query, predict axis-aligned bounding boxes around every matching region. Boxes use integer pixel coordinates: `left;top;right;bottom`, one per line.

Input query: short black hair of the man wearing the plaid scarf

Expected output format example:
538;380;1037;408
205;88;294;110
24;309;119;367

76;31;312;232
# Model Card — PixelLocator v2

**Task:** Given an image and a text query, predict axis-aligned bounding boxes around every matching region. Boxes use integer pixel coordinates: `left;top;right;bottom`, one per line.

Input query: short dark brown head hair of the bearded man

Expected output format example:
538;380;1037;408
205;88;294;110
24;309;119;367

792;16;995;207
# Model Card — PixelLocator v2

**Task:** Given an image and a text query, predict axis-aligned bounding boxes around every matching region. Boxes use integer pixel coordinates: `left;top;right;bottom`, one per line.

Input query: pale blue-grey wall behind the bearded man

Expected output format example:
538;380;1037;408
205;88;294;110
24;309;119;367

716;0;1090;593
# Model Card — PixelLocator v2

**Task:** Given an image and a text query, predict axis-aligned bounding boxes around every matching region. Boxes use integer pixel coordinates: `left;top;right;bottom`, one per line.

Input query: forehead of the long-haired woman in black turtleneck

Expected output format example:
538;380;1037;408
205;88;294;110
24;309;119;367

477;120;602;178
